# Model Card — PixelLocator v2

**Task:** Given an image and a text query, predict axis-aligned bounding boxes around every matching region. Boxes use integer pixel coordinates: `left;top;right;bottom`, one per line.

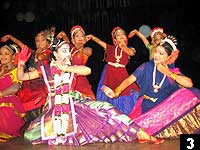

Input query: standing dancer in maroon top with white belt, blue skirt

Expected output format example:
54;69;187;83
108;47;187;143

87;27;139;108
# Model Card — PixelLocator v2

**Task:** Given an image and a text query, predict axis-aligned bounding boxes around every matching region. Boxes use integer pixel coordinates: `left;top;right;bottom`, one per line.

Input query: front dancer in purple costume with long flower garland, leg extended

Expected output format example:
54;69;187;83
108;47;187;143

17;38;163;146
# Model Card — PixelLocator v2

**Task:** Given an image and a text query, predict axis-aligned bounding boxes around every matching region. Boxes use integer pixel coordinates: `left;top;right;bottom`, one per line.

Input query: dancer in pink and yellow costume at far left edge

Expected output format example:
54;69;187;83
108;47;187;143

0;45;24;142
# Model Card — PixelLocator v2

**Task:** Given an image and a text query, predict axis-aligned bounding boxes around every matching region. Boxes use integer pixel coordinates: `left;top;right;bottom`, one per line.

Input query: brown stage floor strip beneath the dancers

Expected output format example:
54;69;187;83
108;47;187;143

0;138;180;150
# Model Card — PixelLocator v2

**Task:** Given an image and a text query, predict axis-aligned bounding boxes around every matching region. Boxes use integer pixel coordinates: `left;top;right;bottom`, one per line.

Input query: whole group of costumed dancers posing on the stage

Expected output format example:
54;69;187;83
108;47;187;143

0;25;200;146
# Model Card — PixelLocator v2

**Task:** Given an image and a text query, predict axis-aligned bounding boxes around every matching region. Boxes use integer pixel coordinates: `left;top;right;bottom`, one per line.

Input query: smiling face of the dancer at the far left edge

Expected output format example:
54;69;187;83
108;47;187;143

0;46;14;64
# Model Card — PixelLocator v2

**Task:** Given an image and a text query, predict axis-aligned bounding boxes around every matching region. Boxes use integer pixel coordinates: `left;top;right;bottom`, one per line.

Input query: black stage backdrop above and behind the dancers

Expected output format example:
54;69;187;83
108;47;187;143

0;0;200;92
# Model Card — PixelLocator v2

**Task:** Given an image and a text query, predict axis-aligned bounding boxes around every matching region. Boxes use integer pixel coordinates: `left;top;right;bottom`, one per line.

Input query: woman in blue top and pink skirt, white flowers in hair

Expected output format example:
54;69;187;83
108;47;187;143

104;36;200;138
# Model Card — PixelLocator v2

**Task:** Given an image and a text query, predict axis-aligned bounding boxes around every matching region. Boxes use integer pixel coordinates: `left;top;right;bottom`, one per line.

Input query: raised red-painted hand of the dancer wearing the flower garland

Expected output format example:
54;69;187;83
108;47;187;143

18;45;31;65
